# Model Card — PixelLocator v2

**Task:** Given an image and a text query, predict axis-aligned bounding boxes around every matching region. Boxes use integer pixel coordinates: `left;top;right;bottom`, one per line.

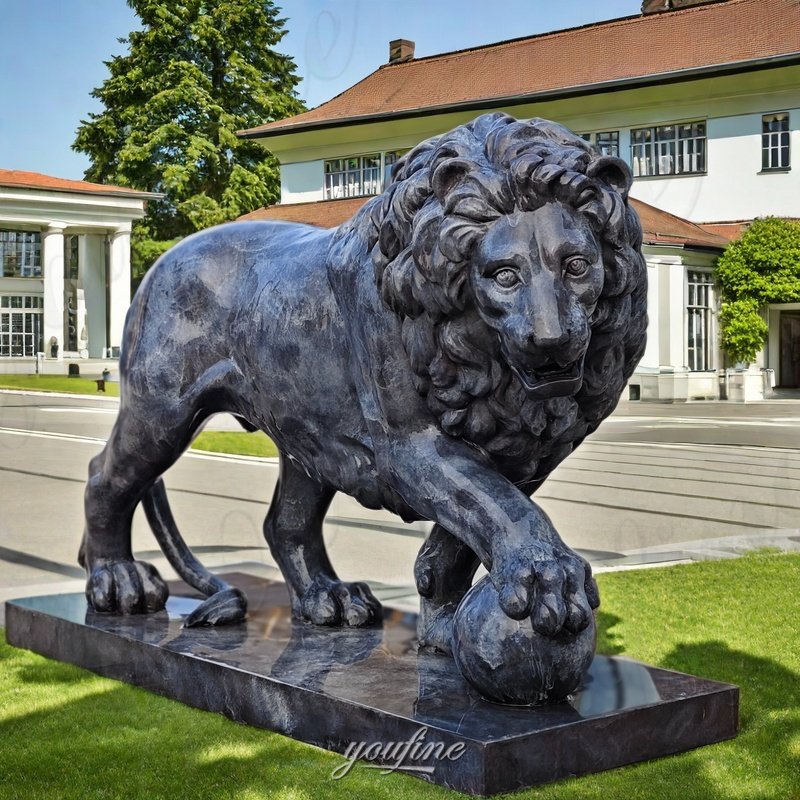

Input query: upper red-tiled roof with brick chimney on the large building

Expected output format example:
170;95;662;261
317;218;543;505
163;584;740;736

241;0;800;137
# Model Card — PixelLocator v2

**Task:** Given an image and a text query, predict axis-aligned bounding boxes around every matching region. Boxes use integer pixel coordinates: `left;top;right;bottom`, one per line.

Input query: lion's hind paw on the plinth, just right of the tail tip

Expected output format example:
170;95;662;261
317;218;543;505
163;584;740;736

300;576;383;627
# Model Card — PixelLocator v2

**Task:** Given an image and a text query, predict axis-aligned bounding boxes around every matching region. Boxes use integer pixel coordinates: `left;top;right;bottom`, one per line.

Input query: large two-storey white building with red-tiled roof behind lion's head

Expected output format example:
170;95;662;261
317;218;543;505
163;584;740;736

240;0;800;399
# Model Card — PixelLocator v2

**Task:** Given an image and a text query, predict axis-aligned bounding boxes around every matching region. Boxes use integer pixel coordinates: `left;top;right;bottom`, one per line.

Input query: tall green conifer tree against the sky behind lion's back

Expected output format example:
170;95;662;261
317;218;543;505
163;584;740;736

73;0;303;274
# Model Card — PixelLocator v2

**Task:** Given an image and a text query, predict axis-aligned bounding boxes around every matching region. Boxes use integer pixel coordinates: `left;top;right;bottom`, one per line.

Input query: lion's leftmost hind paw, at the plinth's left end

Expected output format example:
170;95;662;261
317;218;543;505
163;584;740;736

86;559;169;614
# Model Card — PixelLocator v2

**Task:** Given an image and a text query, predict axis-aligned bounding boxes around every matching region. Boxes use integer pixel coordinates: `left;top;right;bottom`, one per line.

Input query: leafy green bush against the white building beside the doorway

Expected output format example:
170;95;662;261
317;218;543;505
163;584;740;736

716;217;800;361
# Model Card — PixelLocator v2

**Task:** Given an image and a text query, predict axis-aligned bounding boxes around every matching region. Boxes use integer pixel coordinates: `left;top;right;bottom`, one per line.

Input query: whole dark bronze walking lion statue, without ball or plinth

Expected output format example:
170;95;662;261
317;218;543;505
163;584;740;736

80;114;647;688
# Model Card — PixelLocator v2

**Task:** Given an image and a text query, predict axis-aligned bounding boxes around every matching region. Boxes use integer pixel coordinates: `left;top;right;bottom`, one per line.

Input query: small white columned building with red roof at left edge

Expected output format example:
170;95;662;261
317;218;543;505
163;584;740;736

0;169;153;373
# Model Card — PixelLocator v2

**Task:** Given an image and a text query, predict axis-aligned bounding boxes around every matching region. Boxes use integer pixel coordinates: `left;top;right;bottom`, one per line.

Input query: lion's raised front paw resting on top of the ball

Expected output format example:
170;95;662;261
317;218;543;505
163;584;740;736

492;544;600;636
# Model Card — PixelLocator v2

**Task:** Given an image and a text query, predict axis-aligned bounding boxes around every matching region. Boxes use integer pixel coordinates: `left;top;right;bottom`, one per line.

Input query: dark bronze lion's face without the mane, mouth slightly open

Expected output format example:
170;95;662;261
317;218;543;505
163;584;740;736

469;200;603;399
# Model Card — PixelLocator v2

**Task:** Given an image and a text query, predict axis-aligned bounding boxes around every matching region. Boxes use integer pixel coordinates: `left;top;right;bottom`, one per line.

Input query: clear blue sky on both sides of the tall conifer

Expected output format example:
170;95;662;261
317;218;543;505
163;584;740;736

0;0;641;178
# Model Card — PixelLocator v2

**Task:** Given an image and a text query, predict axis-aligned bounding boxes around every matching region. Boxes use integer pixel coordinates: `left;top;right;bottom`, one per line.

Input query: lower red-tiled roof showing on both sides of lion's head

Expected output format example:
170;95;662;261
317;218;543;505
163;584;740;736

239;197;728;250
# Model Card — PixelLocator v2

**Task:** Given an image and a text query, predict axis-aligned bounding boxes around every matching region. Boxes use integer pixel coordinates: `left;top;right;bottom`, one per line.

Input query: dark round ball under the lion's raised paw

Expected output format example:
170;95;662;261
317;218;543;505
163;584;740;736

453;576;596;706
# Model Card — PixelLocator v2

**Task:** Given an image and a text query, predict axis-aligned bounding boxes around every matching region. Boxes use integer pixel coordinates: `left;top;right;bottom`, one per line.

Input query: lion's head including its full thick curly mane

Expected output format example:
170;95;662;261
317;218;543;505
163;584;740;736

346;114;647;482
